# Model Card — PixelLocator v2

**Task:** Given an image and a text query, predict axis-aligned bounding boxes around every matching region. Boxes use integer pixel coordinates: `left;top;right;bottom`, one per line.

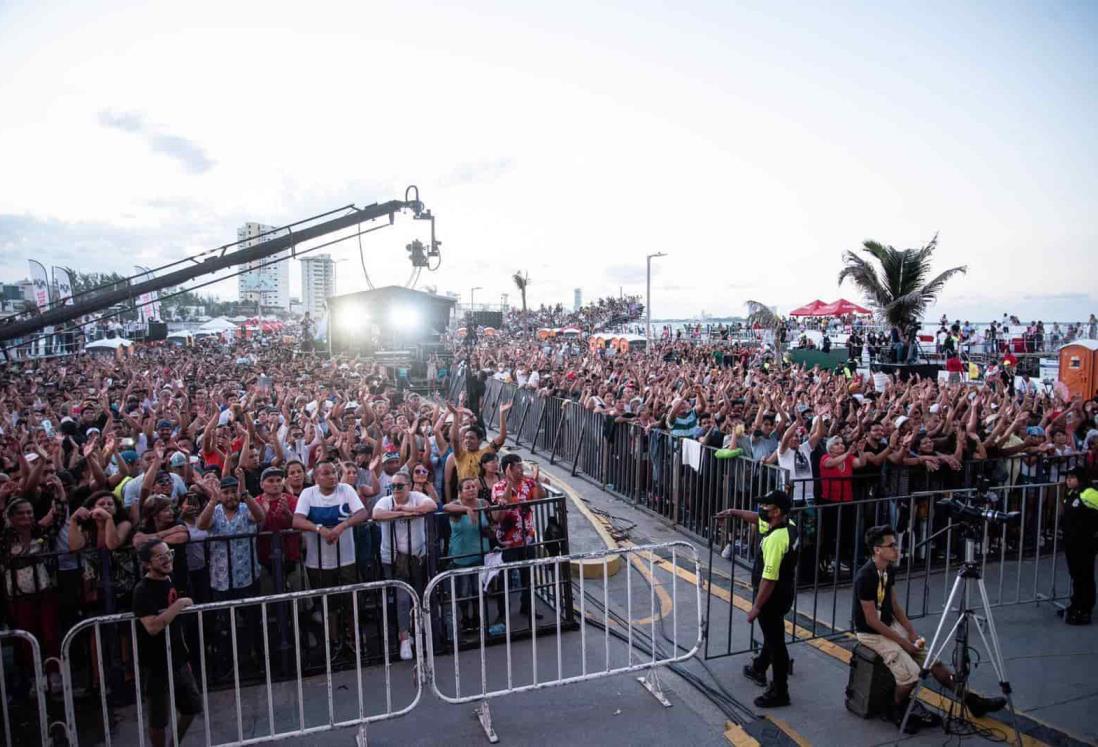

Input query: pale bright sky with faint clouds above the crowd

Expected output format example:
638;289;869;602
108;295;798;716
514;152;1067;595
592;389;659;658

0;0;1098;321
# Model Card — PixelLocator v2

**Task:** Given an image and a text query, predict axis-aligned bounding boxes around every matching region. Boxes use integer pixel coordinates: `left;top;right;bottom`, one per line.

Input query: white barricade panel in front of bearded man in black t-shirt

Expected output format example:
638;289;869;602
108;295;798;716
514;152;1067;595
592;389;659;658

55;579;423;745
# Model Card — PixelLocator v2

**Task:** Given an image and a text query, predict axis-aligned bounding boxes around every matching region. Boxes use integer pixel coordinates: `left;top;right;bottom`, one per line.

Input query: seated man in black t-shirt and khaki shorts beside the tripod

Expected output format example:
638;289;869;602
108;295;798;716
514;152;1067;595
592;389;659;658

852;525;1007;734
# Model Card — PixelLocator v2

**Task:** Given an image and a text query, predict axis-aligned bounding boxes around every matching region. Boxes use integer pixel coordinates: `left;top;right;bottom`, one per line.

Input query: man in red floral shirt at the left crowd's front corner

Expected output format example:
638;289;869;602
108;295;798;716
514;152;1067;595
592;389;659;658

492;454;544;622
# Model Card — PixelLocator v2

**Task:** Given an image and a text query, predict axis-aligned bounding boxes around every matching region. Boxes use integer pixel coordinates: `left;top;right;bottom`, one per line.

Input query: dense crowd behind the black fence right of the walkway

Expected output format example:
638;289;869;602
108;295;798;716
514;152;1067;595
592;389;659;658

458;329;1098;610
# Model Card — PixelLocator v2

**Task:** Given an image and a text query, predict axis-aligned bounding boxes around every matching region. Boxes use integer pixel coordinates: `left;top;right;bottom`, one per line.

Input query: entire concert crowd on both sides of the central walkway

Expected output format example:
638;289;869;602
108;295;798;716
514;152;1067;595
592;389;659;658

0;299;1098;740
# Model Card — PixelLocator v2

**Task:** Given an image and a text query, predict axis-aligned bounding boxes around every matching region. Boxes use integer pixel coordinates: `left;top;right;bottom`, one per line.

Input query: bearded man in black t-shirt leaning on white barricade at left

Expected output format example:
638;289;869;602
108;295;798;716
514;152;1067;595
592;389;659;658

133;539;202;747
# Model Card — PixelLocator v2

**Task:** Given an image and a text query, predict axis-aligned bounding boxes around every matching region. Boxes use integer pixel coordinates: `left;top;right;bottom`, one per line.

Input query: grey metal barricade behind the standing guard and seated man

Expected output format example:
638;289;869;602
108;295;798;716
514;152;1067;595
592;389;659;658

705;483;1068;658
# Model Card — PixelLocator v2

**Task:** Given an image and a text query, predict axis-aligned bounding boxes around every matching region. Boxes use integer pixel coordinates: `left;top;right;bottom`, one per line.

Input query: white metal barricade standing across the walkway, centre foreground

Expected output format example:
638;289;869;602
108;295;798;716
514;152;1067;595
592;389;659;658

424;542;703;743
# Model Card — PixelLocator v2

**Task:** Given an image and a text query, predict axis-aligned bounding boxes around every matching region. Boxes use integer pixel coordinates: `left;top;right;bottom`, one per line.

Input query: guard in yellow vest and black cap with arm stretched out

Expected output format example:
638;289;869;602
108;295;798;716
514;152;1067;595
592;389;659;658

717;490;800;707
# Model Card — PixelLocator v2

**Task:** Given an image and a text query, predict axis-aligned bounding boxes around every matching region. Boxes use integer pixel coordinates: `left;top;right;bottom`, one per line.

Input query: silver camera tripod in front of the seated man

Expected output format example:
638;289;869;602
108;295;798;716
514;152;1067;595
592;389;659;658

900;523;1022;747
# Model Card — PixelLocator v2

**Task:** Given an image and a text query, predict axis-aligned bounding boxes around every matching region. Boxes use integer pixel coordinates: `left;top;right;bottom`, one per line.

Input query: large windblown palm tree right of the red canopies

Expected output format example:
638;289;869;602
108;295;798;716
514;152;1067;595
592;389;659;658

839;234;968;330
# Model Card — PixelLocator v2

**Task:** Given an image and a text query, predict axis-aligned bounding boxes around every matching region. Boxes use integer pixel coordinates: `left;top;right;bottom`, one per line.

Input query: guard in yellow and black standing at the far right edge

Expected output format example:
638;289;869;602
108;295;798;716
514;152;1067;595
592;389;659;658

1060;467;1098;625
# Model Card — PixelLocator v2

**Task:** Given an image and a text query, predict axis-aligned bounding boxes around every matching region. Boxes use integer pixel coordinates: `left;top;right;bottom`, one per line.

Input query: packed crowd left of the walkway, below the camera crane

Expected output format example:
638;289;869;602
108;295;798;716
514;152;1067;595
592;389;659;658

0;339;560;742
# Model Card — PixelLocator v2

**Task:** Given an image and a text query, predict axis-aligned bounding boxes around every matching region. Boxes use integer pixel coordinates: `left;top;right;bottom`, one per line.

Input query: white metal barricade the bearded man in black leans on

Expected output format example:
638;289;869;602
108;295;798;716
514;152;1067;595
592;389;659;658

55;580;423;746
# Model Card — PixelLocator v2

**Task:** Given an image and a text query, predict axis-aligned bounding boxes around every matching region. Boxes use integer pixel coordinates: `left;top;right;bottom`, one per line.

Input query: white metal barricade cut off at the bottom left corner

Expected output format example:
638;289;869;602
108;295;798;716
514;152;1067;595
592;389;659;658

0;629;49;746
